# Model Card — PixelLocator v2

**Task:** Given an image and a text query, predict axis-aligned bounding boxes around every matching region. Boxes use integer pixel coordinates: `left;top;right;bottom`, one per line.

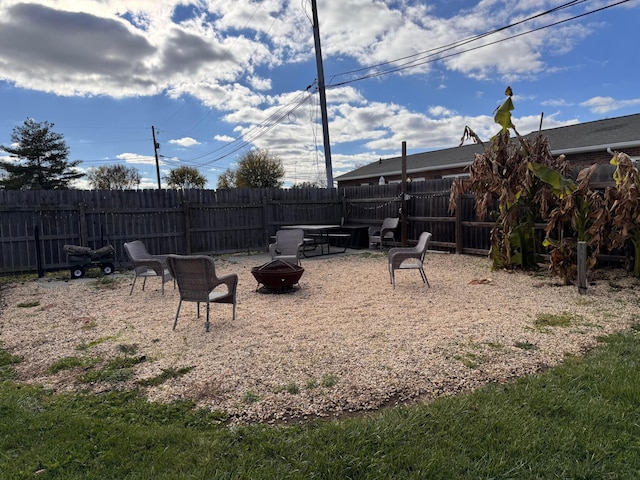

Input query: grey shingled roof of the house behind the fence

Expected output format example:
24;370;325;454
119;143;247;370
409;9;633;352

336;113;640;181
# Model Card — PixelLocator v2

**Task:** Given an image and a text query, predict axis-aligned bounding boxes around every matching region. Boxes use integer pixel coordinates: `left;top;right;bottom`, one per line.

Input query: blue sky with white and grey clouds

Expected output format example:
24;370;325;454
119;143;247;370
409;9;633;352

0;0;640;189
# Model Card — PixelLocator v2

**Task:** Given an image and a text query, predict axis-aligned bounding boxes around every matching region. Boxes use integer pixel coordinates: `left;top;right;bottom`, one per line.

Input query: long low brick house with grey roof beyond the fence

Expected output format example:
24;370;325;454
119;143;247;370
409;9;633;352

336;113;640;188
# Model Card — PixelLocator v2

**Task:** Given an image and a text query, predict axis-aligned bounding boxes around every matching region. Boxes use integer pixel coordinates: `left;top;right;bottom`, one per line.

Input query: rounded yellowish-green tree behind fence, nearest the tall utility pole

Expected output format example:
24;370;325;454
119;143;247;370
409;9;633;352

218;149;286;188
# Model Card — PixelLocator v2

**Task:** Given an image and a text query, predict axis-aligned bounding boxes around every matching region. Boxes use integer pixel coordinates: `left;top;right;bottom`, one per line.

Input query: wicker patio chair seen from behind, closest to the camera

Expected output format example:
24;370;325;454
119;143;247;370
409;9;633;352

167;255;238;332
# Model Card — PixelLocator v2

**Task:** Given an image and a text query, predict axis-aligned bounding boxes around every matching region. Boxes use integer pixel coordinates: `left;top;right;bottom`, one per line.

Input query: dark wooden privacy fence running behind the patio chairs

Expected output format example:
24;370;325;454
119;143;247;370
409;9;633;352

0;180;491;274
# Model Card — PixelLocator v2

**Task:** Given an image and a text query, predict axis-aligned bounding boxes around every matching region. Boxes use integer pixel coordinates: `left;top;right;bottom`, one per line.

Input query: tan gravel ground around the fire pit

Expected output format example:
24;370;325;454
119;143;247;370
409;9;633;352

0;252;640;423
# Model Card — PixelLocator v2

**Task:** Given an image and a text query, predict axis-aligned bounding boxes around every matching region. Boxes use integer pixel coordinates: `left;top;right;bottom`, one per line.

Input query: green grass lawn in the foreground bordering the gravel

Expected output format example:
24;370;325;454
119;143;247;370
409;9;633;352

0;328;640;480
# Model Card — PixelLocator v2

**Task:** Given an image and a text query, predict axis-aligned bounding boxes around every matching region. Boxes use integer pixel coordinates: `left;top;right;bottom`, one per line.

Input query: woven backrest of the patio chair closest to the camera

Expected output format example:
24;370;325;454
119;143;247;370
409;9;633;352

167;255;218;302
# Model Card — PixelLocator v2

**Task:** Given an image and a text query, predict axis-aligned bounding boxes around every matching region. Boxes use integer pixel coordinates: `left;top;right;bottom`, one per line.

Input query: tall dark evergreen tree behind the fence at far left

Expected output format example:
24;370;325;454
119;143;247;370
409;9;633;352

0;118;84;190
